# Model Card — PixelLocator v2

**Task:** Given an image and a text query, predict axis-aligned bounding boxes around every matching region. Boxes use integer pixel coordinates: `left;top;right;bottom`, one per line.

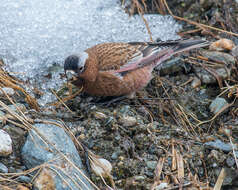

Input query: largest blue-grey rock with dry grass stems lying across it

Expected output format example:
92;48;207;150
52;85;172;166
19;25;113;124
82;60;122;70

21;124;93;190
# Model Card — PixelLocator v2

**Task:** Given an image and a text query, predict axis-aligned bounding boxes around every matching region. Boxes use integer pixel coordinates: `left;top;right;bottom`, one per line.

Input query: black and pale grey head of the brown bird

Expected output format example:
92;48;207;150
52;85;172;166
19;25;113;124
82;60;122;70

64;52;88;74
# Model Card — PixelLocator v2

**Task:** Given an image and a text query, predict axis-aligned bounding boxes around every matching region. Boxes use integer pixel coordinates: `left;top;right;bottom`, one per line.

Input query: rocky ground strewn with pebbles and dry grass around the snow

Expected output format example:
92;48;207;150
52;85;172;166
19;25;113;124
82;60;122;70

0;0;238;190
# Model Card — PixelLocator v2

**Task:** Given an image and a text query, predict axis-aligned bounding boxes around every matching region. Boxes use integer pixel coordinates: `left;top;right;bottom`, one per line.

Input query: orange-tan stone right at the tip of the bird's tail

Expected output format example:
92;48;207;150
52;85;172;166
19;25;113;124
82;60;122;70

209;38;235;51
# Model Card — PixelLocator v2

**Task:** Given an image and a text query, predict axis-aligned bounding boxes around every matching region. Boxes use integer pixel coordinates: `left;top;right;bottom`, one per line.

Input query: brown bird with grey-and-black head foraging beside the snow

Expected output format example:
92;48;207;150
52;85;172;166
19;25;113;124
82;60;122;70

64;40;208;97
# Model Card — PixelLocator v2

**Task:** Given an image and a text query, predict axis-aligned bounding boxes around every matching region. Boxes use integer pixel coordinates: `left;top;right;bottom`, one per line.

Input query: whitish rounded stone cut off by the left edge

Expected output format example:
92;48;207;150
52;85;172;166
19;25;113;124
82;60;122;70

0;129;12;156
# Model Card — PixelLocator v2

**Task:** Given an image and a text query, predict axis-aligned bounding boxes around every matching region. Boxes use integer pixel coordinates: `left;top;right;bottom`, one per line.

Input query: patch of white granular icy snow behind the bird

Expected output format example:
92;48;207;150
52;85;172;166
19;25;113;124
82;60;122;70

0;0;181;105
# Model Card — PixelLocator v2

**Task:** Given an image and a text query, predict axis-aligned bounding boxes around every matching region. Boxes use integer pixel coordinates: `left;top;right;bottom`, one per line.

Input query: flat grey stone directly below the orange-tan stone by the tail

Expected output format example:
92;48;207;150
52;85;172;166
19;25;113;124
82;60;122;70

201;51;235;65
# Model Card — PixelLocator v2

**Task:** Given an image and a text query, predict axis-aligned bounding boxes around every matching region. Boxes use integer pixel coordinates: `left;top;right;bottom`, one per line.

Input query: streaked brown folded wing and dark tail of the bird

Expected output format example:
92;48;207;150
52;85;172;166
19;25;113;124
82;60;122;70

86;40;208;73
